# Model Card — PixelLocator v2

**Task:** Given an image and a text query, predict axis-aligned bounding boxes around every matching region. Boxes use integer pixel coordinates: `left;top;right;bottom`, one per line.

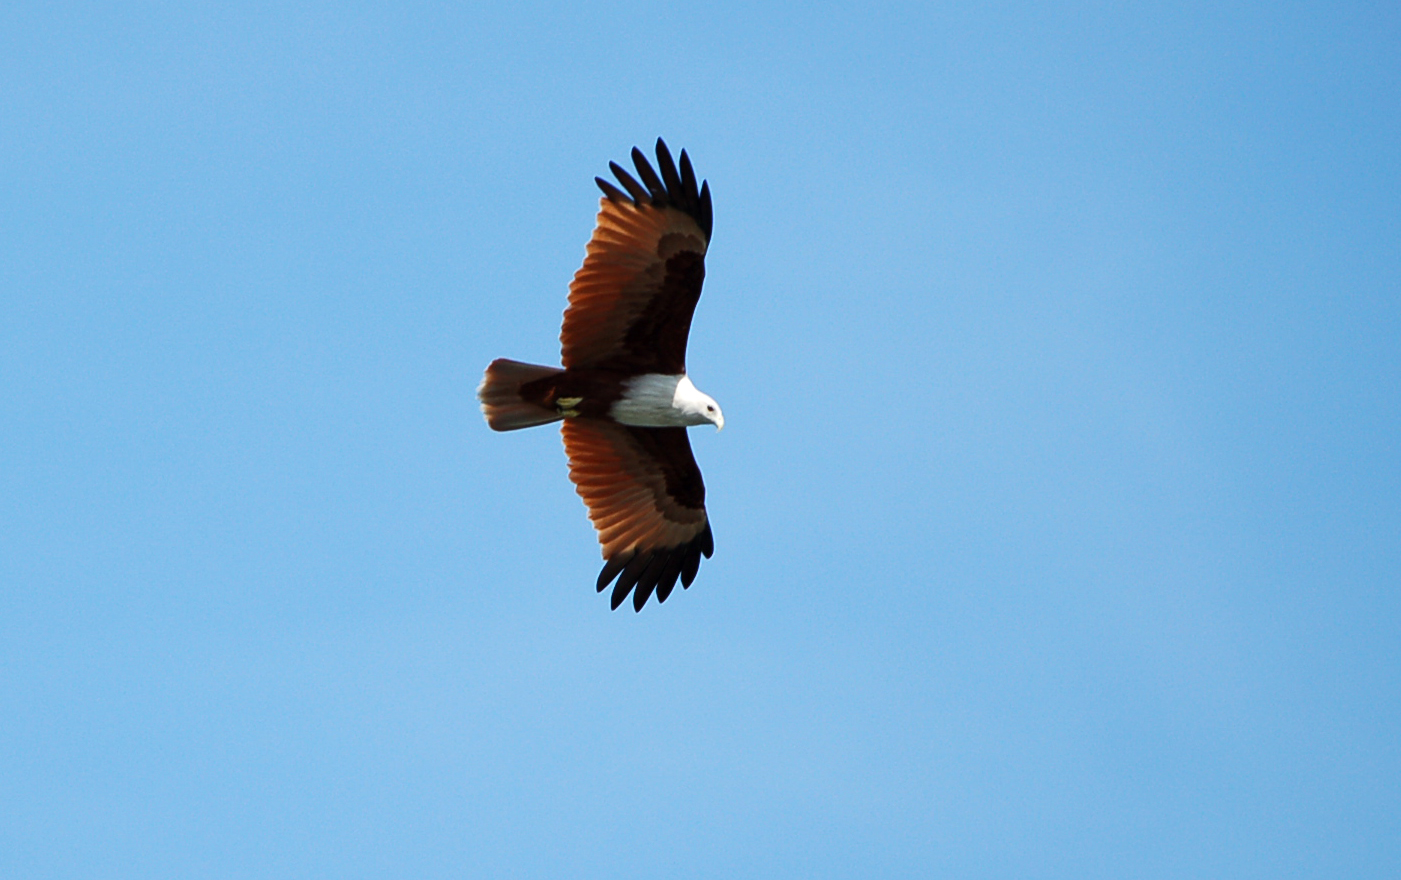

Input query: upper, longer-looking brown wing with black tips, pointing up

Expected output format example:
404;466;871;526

559;137;710;376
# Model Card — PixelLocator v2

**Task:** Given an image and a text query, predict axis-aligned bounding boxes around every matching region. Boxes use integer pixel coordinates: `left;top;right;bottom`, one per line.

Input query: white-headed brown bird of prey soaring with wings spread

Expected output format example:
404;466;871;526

476;137;724;611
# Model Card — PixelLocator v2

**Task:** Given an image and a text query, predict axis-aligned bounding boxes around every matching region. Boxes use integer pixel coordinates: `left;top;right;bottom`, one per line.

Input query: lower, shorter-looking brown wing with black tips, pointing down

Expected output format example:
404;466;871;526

563;418;715;611
